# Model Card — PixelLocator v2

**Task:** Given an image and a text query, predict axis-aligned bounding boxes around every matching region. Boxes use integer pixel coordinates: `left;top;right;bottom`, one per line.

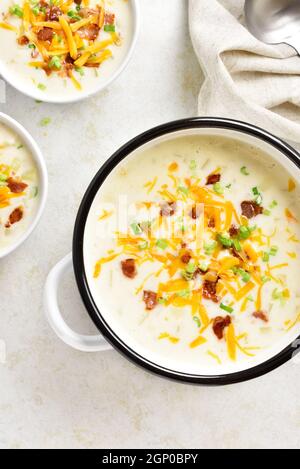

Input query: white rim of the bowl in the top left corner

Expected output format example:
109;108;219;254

0;0;140;104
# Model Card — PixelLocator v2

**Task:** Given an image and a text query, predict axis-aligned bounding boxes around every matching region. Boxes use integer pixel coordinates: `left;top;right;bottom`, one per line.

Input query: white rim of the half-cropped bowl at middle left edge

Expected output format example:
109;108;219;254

0;112;48;259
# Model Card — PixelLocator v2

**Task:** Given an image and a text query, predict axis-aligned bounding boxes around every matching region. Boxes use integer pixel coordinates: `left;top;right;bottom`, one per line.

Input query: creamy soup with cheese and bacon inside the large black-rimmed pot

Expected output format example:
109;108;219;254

84;135;300;371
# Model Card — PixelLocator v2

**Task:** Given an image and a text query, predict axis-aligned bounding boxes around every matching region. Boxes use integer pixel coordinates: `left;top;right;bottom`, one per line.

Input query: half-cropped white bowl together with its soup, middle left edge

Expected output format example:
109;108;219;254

0;113;47;258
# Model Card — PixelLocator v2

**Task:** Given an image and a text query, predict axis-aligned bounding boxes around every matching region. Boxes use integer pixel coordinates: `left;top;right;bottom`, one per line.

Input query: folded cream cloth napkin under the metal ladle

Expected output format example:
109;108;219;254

189;0;300;143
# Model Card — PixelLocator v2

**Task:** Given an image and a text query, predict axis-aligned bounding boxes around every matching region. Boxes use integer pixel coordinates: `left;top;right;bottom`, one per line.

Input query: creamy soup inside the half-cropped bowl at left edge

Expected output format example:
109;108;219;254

0;123;39;254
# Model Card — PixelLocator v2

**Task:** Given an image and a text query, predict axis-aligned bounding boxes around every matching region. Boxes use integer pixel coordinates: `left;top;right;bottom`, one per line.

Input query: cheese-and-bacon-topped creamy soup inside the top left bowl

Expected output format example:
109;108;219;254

0;0;132;99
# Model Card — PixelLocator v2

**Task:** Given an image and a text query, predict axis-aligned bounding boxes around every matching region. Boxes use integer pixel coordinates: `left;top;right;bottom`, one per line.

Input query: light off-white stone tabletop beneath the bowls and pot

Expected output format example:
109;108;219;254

0;0;300;448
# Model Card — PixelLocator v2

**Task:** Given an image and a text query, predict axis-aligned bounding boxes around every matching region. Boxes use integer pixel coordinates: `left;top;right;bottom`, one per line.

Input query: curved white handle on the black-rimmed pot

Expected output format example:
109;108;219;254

44;253;112;352
